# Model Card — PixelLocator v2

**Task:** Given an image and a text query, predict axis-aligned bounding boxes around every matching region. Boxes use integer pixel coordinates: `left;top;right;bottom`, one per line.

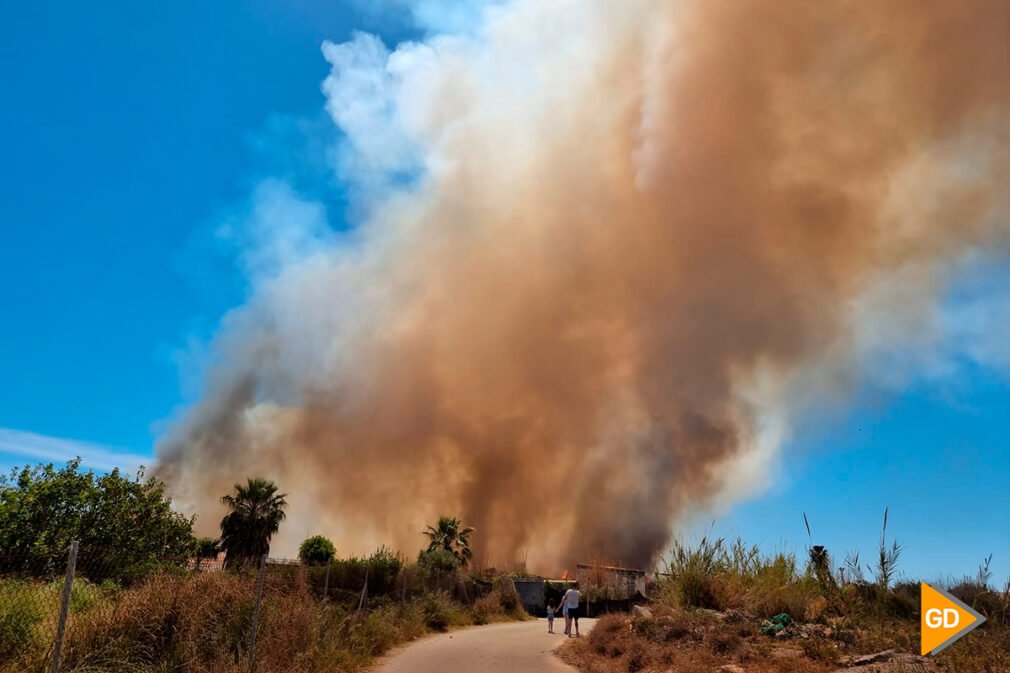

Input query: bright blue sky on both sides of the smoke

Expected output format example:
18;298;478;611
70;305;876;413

0;0;1010;578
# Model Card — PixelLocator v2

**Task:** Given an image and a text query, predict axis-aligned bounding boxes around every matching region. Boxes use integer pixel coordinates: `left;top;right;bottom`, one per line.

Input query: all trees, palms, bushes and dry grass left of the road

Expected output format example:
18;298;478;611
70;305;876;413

0;462;526;673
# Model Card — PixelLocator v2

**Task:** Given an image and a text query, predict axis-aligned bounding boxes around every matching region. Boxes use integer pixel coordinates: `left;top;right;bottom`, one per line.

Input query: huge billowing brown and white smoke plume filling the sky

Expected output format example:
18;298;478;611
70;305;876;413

153;0;1010;568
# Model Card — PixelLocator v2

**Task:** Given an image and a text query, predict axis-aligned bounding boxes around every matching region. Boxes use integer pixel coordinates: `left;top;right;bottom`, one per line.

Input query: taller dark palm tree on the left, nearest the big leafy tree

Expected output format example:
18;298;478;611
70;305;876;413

220;479;288;567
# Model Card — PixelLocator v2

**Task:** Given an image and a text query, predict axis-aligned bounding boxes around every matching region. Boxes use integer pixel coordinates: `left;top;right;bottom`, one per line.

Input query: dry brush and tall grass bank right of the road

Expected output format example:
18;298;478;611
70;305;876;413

563;514;1010;673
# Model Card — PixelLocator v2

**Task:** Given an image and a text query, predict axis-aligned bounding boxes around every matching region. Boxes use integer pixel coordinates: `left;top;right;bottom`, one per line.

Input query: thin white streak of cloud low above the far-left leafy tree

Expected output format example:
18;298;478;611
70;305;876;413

0;427;154;473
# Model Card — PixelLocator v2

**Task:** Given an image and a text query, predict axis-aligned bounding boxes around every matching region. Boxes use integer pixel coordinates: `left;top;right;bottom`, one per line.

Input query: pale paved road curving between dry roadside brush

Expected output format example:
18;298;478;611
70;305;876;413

373;619;594;673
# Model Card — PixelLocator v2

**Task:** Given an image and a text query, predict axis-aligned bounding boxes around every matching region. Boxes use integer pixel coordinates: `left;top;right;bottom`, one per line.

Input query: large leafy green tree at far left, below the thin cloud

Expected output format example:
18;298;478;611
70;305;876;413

0;458;194;579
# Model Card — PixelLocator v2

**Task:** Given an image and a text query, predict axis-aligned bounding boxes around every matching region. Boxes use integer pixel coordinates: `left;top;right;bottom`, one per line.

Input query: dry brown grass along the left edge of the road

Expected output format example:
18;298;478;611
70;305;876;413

0;572;525;673
